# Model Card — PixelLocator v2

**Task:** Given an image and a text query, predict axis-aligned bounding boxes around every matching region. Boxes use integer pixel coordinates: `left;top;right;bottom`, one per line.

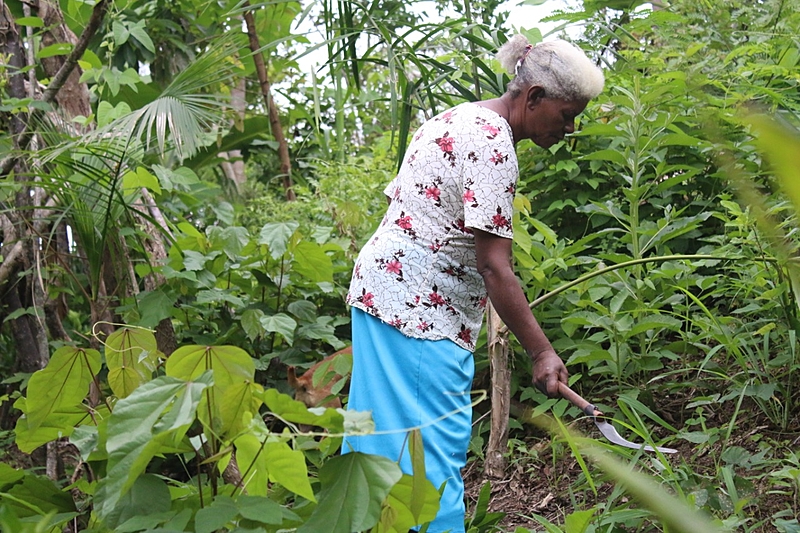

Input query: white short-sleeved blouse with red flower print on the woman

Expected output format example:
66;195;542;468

347;103;519;351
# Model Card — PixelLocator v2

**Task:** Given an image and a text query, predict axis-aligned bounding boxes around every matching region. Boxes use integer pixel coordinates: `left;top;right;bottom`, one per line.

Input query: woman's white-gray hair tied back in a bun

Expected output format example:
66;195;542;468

497;35;605;101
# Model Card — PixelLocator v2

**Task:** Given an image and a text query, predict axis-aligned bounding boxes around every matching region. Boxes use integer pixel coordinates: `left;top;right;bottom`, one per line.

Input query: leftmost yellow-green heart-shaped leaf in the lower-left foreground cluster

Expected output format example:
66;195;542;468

25;346;101;432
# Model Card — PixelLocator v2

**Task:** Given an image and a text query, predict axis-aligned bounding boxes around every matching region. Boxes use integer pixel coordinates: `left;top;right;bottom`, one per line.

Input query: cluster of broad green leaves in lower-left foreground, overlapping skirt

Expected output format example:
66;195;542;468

0;328;439;533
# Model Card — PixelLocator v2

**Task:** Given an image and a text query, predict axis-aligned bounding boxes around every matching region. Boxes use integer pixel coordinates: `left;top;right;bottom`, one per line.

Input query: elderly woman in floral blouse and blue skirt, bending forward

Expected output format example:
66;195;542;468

343;35;603;533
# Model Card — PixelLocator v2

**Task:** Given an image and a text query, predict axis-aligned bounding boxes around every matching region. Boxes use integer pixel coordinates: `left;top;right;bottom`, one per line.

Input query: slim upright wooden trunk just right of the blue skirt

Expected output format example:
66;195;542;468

484;302;511;479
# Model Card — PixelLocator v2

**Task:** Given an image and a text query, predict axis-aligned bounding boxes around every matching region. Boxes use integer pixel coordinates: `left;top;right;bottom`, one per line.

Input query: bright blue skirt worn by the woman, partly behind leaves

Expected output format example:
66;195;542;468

342;308;475;533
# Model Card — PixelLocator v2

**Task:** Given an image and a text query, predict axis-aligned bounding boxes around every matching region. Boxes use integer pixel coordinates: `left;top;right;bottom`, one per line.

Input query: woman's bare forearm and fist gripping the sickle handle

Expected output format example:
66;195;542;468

473;229;568;397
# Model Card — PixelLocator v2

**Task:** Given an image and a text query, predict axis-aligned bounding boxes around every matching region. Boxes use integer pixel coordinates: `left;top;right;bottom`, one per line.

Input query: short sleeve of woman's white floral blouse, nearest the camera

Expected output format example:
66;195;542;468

462;116;519;239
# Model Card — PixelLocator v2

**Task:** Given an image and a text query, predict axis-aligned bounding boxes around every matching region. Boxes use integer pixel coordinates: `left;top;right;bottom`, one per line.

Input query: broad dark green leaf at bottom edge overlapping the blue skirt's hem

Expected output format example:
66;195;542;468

297;452;403;533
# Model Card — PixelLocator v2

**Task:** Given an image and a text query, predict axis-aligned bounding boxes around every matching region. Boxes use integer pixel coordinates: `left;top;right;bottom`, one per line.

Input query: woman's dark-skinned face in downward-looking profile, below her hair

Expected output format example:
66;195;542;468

520;87;588;148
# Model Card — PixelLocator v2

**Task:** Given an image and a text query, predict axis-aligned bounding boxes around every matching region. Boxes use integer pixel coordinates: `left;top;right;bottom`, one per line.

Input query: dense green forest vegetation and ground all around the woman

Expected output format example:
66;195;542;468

0;0;800;533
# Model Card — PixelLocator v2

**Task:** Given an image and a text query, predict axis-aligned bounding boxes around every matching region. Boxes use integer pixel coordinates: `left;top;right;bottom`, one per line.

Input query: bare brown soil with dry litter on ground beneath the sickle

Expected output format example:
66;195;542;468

464;384;800;533
